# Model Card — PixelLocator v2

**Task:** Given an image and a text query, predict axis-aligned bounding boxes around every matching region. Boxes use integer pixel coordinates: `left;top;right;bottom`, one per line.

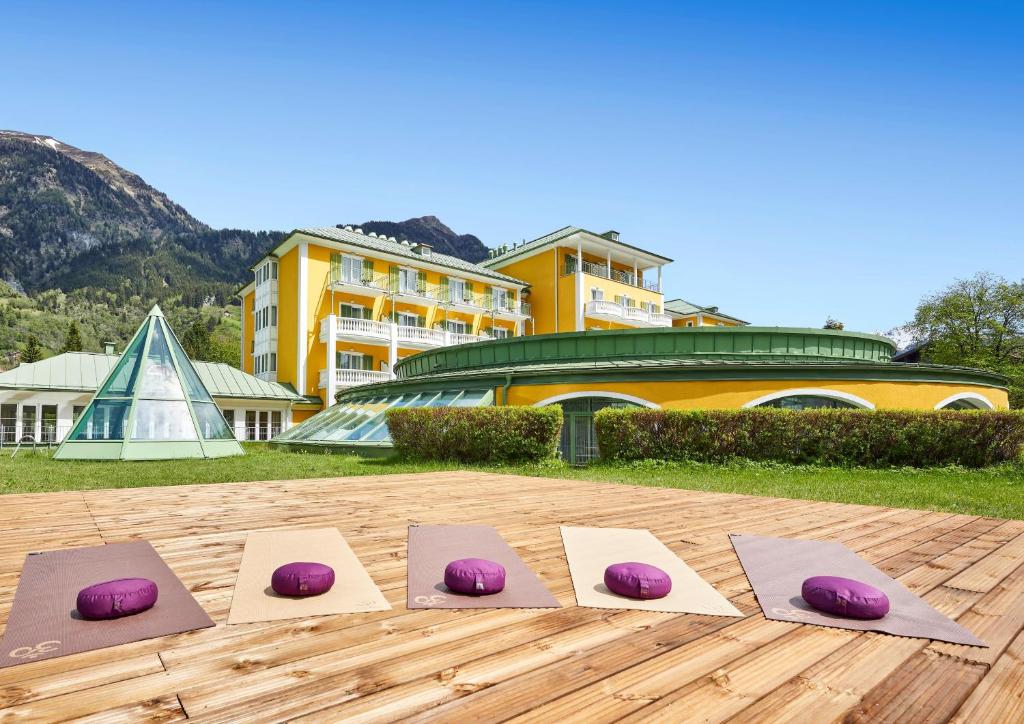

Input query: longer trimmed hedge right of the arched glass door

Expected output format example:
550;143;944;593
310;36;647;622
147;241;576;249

595;409;1024;468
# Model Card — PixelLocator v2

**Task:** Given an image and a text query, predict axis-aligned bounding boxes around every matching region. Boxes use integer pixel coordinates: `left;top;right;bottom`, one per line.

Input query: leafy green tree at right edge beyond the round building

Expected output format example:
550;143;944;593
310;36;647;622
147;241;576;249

907;272;1024;408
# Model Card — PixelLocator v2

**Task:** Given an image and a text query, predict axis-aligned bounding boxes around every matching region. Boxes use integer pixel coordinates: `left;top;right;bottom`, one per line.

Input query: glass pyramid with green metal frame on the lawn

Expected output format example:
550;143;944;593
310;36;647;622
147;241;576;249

53;306;243;460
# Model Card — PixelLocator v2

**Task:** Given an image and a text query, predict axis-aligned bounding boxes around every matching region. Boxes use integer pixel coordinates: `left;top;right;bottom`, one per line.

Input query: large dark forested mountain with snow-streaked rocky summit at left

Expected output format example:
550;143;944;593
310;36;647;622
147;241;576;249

0;131;283;301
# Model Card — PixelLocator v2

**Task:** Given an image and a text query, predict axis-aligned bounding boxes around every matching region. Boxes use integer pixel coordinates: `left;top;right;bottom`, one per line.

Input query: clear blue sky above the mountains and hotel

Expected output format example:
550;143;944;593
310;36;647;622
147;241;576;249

0;1;1024;331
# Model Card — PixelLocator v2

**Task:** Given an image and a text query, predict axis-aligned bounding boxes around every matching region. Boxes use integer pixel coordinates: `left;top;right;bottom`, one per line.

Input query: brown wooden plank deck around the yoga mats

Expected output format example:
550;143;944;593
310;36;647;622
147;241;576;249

0;473;1024;723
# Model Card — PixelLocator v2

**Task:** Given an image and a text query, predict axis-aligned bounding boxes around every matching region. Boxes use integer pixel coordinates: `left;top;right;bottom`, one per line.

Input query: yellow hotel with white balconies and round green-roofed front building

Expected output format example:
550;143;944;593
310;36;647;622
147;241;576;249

242;226;1008;461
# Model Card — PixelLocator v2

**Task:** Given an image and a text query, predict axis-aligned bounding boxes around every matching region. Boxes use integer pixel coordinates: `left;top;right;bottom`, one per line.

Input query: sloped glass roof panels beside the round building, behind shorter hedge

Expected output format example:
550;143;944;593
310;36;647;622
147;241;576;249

271;389;495;448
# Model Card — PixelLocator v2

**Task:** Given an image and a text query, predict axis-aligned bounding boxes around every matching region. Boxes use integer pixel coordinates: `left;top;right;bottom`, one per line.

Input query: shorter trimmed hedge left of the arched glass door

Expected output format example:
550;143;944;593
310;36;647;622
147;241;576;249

386;404;562;463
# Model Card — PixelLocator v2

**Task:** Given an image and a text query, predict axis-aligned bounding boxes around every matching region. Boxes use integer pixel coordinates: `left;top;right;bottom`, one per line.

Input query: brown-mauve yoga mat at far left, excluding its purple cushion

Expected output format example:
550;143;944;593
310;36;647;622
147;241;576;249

0;541;213;668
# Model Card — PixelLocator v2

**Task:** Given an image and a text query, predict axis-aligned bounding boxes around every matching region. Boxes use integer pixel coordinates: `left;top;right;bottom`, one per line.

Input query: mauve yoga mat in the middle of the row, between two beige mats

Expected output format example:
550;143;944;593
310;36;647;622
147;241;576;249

408;525;561;608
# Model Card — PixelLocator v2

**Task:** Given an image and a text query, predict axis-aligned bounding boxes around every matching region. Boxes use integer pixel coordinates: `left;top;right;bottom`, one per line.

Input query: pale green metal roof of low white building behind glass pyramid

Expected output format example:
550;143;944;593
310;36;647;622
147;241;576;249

0;352;303;402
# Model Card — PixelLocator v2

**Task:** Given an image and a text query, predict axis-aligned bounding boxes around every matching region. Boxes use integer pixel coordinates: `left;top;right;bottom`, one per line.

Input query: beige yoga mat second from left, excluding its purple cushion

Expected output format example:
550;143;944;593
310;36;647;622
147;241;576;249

227;528;391;624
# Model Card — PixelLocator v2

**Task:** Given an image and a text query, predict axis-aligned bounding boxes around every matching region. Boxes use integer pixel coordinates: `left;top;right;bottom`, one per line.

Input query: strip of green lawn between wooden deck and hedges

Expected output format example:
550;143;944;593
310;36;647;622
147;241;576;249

0;443;1024;519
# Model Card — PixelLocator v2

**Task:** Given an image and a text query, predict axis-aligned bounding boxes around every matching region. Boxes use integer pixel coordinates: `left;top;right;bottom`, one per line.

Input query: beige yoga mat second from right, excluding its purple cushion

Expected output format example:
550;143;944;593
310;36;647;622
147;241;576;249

562;525;743;616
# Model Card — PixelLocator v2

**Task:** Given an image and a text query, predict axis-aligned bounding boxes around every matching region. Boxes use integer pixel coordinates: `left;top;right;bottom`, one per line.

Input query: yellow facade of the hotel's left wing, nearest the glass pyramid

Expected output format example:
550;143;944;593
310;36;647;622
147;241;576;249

242;232;525;406
